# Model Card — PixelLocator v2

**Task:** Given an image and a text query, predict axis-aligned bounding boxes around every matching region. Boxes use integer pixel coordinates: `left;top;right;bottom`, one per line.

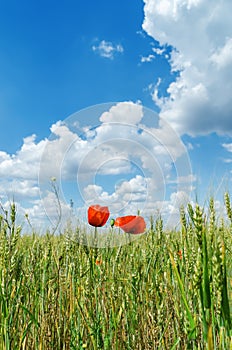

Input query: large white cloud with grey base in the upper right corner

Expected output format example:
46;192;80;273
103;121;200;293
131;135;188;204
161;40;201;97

143;0;232;135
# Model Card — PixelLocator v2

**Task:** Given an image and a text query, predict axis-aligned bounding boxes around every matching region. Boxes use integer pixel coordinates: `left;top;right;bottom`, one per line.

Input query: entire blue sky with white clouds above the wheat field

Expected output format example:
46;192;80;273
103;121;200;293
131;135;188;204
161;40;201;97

0;0;232;231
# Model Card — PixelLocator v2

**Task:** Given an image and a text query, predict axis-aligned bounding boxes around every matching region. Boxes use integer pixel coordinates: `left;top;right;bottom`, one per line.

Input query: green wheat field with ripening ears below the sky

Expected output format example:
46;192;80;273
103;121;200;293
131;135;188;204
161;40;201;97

0;194;232;350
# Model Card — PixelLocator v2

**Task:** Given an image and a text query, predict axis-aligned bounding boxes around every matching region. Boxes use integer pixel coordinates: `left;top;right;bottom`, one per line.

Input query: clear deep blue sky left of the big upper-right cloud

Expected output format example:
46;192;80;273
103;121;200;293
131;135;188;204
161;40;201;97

0;1;163;152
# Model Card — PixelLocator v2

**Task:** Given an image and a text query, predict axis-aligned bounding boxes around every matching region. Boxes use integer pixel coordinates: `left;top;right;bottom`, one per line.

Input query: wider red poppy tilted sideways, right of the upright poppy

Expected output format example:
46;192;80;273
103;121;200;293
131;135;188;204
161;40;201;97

114;215;146;235
